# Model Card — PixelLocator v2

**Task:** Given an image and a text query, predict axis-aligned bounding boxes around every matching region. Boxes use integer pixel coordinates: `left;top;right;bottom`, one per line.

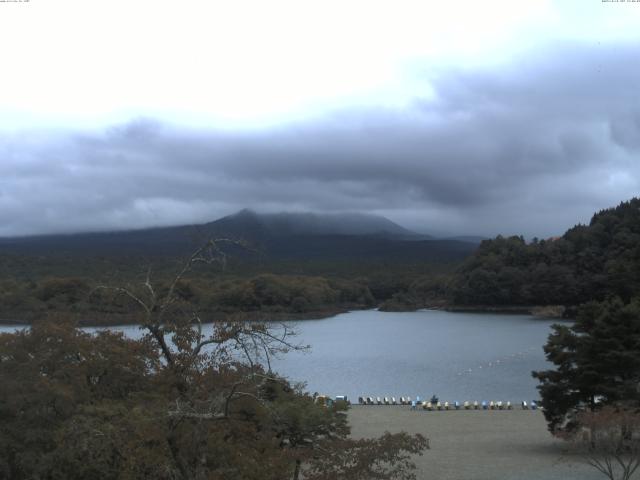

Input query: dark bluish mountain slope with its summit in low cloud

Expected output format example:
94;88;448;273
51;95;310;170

0;210;475;262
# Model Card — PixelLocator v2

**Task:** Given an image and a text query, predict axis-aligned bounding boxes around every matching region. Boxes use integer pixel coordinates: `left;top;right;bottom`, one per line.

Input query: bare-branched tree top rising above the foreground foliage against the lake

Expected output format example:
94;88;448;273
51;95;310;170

98;239;309;419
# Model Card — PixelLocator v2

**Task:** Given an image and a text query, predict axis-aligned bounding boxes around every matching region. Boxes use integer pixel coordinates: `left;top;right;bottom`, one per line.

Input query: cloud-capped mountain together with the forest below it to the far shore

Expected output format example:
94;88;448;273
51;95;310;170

0;210;476;325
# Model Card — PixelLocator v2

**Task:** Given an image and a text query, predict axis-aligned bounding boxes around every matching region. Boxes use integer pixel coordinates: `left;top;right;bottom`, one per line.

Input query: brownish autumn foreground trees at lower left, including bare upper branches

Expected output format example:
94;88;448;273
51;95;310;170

0;242;427;480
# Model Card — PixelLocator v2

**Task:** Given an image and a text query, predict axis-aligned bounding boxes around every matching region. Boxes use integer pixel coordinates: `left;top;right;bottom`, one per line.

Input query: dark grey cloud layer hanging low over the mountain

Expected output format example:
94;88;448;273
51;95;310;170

0;45;640;236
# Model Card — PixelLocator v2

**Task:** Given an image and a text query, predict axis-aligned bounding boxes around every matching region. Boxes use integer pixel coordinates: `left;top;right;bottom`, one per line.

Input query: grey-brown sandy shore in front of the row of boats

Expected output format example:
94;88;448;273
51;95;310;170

349;405;603;480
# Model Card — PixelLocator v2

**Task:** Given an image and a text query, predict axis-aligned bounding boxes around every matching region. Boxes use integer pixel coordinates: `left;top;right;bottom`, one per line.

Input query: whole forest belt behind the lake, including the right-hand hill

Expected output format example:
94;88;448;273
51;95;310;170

5;198;640;324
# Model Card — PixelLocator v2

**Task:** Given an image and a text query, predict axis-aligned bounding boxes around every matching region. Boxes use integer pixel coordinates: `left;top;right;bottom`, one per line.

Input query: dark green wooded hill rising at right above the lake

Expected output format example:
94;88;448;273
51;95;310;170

449;198;640;305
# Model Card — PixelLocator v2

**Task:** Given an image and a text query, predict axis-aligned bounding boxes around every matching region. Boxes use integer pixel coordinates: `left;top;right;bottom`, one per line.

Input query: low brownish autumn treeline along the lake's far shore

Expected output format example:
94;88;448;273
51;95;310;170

0;274;452;325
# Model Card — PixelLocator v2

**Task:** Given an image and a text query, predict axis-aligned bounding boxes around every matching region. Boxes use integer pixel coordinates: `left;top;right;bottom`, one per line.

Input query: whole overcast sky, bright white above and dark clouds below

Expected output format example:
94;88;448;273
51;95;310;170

0;0;640;238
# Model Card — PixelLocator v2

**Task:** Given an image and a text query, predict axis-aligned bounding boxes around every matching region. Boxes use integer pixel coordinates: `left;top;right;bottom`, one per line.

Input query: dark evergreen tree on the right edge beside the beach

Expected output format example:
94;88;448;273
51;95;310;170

533;298;640;433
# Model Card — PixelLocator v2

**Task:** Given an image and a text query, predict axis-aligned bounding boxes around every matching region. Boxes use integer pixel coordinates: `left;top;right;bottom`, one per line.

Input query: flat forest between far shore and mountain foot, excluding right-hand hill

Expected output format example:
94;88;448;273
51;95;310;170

0;248;456;325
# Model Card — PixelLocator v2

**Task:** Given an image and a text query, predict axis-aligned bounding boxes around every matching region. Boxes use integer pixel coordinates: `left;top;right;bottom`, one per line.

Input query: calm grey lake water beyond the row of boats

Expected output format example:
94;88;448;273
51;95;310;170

0;310;554;402
